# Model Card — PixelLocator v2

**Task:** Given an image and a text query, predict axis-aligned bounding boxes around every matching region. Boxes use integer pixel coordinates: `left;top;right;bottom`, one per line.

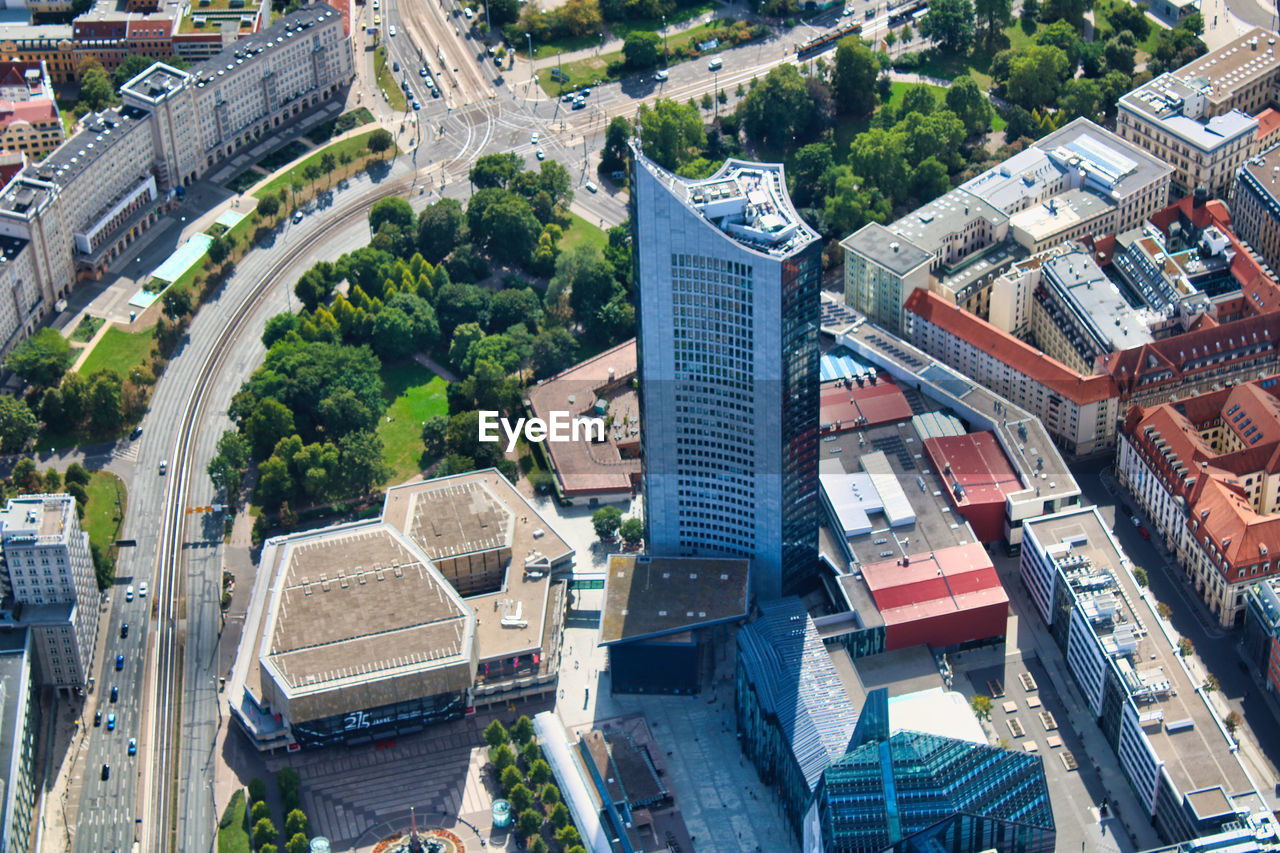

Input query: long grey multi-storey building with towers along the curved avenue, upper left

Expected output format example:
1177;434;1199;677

0;3;355;356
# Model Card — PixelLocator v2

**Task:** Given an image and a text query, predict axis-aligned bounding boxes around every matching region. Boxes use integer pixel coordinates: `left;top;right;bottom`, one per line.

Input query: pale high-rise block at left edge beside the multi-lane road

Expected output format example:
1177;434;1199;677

0;494;99;692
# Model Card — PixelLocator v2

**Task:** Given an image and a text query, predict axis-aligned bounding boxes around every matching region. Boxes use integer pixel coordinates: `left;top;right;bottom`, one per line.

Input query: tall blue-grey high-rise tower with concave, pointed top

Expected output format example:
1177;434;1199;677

631;151;822;598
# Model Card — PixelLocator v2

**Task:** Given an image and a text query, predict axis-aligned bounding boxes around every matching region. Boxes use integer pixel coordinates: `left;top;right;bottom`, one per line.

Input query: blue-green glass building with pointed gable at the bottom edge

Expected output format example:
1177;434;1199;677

805;688;1056;853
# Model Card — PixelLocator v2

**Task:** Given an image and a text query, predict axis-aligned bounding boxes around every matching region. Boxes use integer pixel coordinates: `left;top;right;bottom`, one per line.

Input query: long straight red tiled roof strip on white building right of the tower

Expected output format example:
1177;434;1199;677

902;288;1116;406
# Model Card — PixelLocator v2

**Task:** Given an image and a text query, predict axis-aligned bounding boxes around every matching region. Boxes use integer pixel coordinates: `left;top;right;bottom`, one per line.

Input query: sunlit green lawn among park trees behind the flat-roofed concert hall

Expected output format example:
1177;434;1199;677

378;361;449;483
